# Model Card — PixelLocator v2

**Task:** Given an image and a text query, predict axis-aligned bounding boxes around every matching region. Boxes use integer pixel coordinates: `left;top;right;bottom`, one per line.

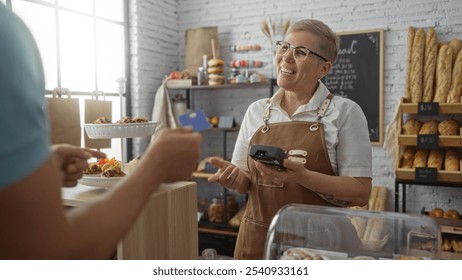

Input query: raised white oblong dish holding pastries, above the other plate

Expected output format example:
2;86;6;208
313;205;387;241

84;121;157;139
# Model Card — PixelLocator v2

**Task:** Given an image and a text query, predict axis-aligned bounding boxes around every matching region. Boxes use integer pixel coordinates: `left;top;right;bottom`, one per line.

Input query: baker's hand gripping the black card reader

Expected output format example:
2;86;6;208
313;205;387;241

255;159;308;185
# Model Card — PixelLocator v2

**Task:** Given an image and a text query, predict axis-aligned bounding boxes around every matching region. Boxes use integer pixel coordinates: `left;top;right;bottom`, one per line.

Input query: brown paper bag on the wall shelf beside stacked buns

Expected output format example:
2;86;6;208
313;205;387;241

185;26;220;76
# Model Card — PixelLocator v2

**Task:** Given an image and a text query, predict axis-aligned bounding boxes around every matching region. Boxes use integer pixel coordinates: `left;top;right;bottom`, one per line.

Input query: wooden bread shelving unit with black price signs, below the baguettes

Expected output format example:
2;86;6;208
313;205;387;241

395;99;462;212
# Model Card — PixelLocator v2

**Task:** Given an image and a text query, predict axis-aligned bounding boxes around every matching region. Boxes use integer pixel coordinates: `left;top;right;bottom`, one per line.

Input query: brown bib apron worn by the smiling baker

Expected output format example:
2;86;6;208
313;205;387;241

234;94;335;259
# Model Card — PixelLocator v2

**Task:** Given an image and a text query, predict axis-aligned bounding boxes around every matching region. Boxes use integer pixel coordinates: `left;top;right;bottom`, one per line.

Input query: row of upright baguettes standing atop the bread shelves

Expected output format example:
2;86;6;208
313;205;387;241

405;26;462;103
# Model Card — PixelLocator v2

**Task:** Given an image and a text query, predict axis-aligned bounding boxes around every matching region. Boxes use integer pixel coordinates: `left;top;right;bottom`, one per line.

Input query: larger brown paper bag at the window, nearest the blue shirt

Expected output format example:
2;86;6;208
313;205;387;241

47;88;82;146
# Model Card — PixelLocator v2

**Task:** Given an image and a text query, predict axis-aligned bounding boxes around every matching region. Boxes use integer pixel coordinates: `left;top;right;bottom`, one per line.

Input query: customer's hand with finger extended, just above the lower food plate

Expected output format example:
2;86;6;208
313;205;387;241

51;144;106;187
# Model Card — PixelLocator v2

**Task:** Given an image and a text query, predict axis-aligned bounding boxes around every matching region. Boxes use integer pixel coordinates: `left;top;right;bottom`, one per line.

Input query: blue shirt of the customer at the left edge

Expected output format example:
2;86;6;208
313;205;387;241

0;3;50;191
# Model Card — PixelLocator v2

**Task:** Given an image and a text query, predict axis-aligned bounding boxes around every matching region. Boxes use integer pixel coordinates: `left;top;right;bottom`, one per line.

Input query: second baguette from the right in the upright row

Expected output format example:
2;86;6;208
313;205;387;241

433;45;453;103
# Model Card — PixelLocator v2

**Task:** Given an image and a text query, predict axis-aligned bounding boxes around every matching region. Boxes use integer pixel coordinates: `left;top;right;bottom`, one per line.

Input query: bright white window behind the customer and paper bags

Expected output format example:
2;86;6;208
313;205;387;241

7;0;128;160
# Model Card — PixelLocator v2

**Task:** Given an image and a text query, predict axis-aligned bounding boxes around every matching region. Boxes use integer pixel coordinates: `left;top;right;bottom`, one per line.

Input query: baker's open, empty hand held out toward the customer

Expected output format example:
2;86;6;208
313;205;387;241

208;157;250;193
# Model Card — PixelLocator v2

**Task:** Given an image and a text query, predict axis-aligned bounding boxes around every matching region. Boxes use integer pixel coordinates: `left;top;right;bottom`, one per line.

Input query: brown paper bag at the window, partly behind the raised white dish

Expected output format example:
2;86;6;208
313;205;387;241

84;92;112;149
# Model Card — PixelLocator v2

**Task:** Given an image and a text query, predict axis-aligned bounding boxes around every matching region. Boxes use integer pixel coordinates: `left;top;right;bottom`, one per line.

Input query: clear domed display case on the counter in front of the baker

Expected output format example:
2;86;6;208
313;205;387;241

264;204;441;260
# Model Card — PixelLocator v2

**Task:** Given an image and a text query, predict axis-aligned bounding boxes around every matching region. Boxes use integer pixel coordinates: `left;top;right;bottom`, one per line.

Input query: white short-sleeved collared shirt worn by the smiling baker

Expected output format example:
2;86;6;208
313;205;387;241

232;82;372;178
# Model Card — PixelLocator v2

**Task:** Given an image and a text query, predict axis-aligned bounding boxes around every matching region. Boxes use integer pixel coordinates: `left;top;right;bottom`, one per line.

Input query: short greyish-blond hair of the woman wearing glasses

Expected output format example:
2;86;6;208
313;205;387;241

287;19;339;63
